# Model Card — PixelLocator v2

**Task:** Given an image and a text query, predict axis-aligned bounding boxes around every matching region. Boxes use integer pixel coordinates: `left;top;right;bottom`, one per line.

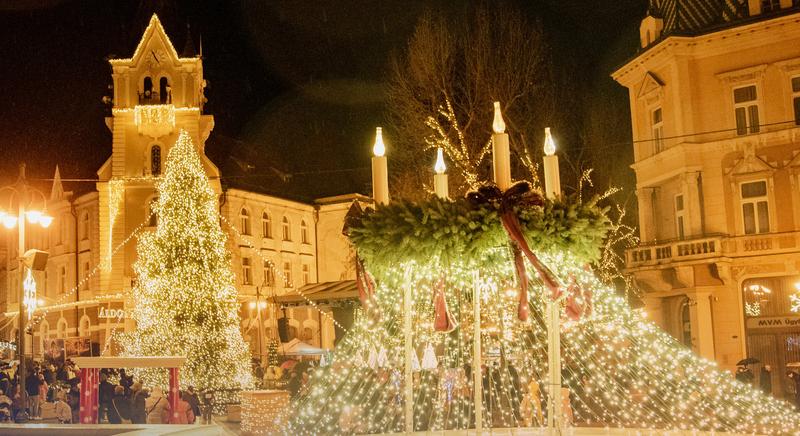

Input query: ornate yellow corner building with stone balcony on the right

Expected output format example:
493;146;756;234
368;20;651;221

612;0;800;395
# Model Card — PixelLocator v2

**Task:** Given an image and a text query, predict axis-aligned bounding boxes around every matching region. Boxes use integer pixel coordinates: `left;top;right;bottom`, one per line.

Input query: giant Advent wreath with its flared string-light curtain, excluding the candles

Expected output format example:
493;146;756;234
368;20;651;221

284;186;800;435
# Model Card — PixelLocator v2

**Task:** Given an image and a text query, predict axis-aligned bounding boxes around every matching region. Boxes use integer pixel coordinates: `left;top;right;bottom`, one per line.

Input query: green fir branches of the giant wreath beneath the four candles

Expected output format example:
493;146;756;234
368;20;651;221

349;195;612;271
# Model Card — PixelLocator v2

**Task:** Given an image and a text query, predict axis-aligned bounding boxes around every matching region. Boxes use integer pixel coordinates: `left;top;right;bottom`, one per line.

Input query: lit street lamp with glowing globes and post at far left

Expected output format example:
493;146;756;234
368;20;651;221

0;164;53;422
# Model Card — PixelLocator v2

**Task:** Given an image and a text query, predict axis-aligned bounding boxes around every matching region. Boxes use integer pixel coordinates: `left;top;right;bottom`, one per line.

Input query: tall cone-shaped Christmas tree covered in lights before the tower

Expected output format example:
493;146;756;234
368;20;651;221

122;130;253;390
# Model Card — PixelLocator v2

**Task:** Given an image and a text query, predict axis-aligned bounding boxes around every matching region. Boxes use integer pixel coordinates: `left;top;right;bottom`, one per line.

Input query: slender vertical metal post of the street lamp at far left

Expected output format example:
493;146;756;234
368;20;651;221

17;164;33;422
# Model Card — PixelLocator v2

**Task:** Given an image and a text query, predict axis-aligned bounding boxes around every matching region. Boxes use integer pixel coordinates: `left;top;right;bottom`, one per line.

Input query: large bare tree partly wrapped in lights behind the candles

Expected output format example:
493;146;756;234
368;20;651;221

388;4;578;197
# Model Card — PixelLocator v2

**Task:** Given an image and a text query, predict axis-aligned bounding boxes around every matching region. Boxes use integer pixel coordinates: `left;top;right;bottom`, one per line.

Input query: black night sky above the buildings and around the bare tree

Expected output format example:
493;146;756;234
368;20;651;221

0;0;647;198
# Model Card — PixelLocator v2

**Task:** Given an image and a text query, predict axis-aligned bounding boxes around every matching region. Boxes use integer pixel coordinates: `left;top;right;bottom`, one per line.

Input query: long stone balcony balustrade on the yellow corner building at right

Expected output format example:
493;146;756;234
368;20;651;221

626;231;800;268
